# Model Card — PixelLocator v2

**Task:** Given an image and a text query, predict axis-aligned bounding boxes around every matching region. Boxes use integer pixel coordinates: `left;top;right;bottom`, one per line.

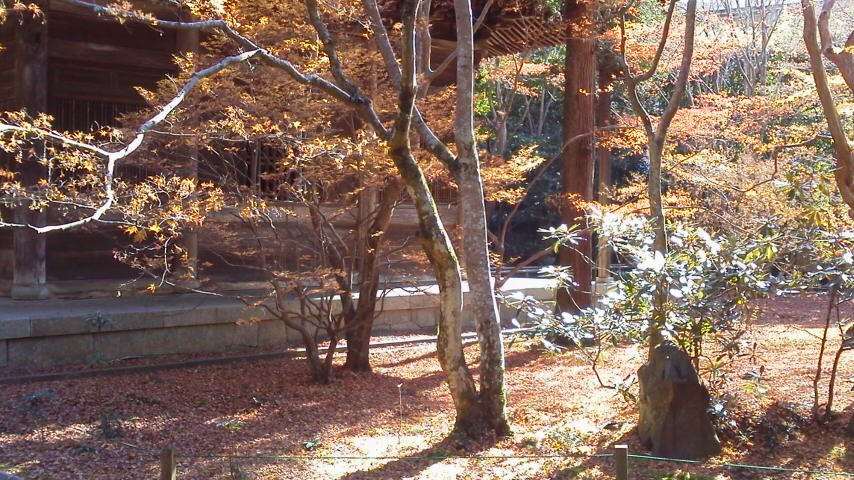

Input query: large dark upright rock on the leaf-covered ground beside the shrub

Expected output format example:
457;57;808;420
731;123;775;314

638;342;721;459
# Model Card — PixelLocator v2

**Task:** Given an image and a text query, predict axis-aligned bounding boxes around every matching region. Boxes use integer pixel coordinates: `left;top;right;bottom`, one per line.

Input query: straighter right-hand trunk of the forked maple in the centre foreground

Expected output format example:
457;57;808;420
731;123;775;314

454;0;510;435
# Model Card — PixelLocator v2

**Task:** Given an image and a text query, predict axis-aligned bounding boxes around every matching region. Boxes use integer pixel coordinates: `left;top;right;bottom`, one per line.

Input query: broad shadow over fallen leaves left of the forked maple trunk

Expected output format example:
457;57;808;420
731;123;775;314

0;342;536;478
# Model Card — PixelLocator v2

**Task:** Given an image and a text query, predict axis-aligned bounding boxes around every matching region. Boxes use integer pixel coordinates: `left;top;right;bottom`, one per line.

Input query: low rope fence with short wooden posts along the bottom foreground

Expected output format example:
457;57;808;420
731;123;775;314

105;441;854;480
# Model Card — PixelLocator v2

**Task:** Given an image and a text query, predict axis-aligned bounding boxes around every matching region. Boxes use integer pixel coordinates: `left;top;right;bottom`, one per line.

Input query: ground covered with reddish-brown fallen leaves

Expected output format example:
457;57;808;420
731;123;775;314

0;298;854;480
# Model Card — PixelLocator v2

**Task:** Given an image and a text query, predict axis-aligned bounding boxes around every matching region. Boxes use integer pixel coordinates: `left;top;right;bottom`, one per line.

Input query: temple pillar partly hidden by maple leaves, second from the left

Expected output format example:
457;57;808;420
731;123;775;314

175;24;199;288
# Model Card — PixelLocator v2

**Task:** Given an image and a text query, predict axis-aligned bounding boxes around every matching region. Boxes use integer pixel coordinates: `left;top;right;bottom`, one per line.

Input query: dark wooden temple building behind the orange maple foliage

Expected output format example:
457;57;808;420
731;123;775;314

0;0;563;299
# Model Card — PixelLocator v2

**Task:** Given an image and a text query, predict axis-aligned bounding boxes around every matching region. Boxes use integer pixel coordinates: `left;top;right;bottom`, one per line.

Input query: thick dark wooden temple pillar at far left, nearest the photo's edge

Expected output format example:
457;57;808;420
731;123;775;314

11;14;49;300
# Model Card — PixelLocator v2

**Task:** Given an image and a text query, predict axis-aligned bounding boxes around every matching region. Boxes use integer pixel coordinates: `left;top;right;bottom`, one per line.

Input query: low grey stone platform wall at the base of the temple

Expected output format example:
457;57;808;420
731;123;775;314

0;279;553;372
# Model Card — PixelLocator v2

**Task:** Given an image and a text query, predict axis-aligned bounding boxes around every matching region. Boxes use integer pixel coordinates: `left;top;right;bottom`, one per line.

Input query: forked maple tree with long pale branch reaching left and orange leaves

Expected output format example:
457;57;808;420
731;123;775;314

2;0;532;435
